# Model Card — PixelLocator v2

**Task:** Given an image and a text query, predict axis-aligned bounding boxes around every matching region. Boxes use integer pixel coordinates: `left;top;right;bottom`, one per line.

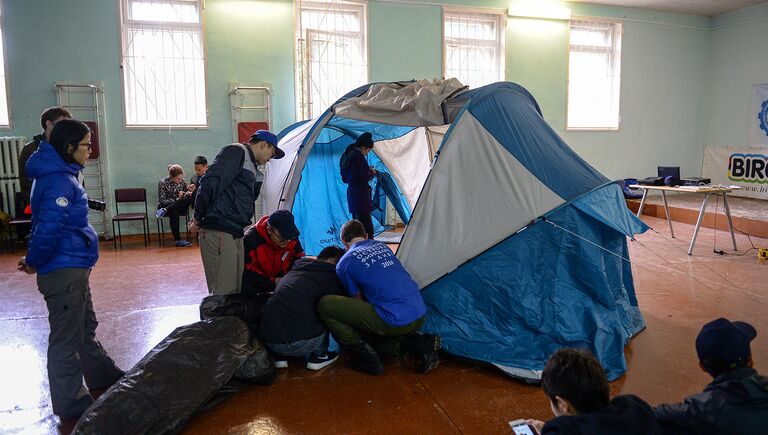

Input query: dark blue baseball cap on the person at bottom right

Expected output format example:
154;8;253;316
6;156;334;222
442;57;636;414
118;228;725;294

696;317;757;370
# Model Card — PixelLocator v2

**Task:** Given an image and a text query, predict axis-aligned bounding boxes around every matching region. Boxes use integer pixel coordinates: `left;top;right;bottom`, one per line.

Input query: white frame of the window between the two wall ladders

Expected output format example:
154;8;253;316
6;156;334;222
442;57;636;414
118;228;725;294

117;0;210;130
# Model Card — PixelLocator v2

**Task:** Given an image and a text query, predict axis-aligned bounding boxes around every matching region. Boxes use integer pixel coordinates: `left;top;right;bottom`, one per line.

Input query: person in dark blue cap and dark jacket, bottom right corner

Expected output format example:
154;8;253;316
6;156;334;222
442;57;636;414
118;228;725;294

653;318;768;434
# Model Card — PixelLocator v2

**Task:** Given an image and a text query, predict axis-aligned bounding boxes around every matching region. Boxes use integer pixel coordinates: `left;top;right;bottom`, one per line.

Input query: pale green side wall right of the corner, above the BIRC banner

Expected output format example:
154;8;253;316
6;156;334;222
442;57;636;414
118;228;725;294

705;4;768;146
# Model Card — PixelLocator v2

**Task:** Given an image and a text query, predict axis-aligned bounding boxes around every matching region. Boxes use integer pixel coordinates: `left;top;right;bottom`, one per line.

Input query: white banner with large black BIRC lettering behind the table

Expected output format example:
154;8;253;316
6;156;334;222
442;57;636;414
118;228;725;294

702;146;768;200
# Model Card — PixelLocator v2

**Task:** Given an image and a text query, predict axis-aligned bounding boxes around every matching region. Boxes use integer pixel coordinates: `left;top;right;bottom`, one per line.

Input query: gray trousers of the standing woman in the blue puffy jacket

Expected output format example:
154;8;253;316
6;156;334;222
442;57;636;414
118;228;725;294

37;269;123;418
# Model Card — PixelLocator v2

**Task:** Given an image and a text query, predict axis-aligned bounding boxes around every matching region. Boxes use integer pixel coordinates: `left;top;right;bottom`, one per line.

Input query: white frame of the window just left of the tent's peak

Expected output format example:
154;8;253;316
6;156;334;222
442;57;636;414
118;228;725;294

294;0;370;120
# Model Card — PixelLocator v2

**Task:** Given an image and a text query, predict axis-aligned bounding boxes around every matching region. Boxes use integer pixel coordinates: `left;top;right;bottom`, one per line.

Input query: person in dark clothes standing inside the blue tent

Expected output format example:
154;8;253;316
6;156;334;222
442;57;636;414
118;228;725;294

339;133;376;239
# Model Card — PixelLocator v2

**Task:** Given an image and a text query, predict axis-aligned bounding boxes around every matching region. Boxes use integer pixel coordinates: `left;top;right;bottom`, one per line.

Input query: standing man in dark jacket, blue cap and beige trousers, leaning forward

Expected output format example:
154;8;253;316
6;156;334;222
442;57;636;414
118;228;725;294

189;130;285;294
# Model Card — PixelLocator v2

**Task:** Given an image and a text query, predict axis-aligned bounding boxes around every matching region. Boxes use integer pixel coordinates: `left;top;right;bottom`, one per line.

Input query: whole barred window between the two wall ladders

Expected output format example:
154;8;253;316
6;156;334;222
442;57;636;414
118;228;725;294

120;0;208;127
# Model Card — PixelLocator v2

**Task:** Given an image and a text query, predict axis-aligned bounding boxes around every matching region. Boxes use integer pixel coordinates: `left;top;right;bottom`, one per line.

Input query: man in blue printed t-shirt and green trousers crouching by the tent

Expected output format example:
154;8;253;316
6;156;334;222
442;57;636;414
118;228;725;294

317;220;440;375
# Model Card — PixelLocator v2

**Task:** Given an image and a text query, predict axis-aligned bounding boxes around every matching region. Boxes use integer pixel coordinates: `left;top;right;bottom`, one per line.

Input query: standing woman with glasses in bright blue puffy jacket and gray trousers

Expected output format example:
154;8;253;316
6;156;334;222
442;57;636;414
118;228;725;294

18;119;123;419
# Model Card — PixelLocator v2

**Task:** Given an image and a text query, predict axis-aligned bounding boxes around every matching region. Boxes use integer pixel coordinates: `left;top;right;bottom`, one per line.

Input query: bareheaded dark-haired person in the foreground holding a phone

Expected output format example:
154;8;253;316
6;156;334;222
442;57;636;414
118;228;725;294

528;349;661;435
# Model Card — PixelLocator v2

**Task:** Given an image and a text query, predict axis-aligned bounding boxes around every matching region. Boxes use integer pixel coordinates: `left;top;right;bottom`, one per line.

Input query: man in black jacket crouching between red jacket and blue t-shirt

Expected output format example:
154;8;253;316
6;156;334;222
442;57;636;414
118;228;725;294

259;246;344;370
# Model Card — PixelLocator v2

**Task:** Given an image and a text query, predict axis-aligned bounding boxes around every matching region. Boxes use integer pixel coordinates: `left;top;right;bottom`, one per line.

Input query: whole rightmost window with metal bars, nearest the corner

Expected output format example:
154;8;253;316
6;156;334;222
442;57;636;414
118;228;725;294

567;19;621;130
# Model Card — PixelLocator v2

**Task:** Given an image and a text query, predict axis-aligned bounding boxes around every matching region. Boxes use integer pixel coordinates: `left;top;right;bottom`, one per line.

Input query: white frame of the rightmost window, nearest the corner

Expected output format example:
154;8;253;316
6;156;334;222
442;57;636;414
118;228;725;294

565;17;624;131
